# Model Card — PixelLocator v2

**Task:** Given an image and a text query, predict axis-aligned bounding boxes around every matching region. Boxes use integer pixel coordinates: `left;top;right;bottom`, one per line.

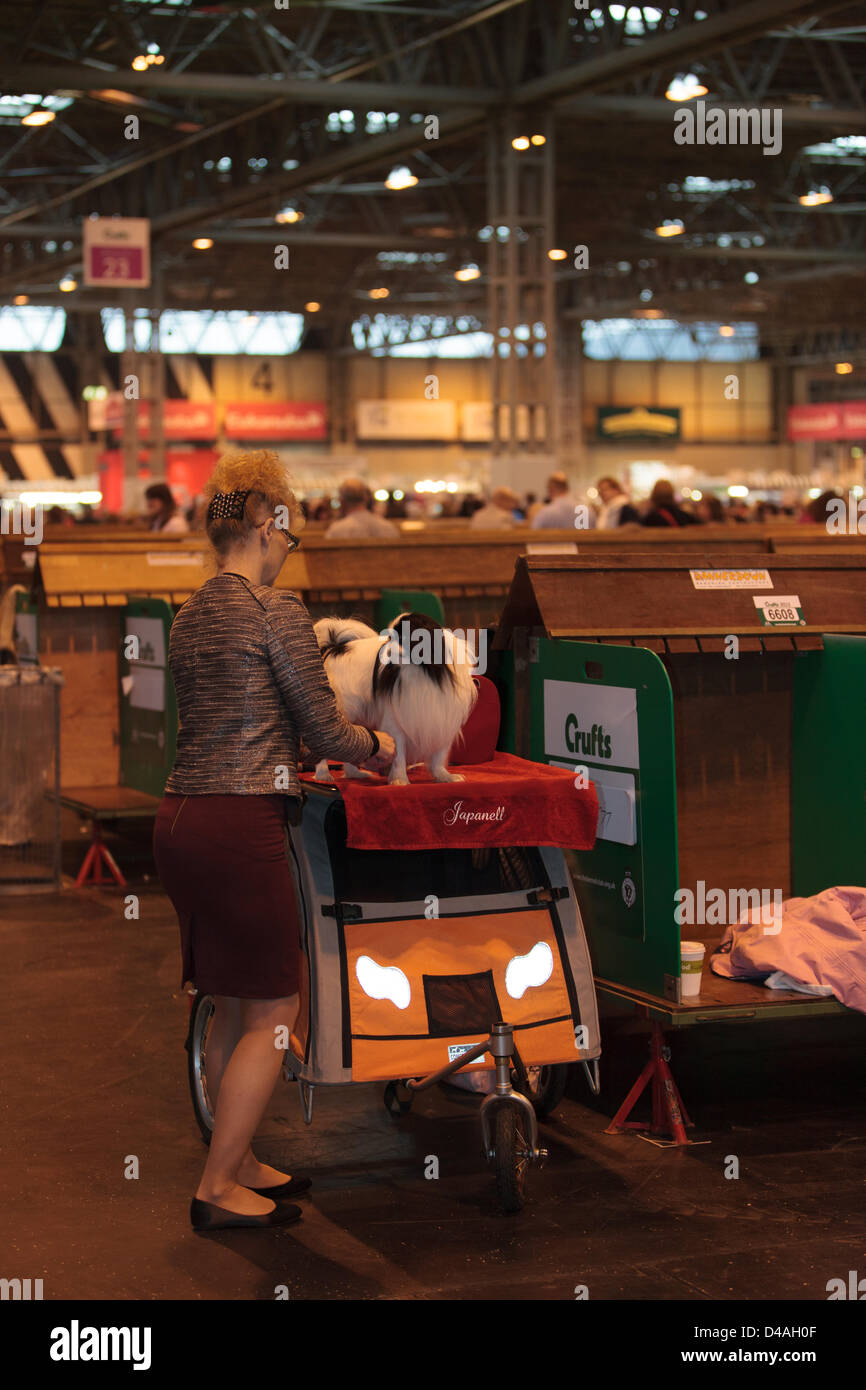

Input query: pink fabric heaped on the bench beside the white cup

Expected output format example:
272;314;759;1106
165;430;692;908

710;888;866;1013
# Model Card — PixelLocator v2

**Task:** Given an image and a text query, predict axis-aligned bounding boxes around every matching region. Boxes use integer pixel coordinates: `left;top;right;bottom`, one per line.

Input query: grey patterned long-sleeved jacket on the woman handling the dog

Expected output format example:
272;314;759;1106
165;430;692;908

165;573;373;796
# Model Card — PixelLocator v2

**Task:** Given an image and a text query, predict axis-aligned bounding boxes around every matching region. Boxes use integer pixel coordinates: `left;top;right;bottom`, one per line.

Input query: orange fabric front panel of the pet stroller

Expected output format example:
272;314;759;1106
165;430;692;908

343;909;574;1080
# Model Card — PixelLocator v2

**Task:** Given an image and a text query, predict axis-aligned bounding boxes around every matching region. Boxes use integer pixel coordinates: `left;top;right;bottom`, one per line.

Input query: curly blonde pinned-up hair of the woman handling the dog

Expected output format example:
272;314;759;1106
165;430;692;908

204;449;303;557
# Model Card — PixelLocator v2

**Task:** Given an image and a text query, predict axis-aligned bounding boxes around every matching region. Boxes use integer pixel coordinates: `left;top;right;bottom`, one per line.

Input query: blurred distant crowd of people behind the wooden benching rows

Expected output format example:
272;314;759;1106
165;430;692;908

16;473;841;528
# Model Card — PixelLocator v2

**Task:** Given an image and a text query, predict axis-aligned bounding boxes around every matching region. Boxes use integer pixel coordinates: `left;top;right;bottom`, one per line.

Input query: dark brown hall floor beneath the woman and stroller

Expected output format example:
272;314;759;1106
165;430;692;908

0;817;866;1300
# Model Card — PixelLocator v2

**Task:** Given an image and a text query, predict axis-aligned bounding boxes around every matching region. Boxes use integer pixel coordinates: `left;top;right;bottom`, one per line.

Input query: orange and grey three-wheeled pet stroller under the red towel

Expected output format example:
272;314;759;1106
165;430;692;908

186;753;601;1212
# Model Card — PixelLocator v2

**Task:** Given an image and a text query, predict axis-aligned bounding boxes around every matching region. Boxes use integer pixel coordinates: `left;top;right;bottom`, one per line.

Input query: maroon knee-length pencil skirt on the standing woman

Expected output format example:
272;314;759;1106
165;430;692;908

153;794;299;999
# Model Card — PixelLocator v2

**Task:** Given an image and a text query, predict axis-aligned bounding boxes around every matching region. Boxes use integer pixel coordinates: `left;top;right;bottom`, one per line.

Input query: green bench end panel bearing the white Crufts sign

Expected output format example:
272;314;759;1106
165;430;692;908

530;638;680;999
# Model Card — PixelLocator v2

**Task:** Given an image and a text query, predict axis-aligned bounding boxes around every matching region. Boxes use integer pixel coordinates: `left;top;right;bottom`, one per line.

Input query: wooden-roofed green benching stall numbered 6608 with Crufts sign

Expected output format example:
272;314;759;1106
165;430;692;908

495;555;866;1022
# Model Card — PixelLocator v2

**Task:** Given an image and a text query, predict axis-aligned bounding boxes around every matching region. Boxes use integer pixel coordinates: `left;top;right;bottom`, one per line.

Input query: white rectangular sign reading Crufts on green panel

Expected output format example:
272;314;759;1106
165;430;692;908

545;681;641;767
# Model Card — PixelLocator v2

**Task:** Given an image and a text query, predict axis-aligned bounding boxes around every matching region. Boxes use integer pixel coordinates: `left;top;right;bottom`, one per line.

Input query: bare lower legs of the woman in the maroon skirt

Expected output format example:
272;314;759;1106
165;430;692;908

196;998;296;1215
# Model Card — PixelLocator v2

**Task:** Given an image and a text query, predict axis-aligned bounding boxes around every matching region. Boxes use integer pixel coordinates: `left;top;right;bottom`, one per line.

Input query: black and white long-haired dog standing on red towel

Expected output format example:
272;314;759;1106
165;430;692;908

316;613;478;785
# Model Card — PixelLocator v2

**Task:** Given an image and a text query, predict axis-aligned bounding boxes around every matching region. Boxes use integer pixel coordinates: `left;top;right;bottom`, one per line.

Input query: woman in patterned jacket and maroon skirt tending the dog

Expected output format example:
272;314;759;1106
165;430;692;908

154;450;395;1230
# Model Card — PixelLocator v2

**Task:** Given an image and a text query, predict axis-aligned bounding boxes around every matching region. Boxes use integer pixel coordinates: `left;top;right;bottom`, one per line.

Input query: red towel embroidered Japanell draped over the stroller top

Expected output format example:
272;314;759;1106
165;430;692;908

303;753;598;849
